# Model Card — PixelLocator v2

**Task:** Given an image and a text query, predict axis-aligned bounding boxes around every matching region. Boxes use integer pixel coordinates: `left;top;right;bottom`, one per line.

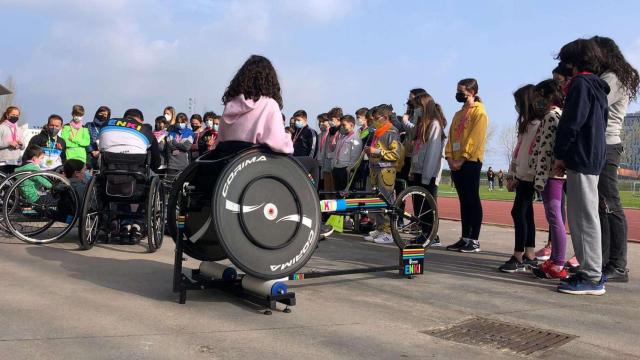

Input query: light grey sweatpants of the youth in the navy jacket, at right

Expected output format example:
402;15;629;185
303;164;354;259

567;170;602;281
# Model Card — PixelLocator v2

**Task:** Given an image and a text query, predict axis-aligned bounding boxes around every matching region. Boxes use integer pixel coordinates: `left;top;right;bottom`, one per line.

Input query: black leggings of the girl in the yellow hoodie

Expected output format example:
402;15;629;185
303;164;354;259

451;161;482;240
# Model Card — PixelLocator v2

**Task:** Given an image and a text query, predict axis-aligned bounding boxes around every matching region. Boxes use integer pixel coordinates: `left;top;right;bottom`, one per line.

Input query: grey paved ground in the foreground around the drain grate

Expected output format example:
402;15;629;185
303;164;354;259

0;221;640;360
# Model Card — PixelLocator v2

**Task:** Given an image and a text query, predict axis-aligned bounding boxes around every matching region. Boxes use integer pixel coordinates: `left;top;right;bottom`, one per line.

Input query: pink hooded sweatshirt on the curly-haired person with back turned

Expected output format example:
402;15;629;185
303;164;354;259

218;95;293;154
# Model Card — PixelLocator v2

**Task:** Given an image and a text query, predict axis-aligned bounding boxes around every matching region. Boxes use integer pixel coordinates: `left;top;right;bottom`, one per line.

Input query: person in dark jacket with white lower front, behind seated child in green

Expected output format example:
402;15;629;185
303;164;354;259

29;114;67;170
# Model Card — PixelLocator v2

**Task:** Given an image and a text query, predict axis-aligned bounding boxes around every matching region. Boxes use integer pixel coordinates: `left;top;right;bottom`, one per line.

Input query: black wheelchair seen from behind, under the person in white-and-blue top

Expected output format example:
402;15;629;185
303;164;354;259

78;152;165;252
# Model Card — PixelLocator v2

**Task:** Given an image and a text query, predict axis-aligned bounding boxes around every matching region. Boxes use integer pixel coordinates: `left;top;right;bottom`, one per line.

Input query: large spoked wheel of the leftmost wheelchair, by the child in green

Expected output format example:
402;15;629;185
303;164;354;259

3;171;79;245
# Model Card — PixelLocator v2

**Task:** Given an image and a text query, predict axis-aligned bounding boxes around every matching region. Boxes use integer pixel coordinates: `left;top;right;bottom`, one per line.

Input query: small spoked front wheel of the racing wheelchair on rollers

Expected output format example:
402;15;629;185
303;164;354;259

391;186;438;248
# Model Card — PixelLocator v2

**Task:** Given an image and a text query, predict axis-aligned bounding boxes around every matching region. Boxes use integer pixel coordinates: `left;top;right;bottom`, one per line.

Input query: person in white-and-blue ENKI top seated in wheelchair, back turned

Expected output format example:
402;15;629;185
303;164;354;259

98;109;161;244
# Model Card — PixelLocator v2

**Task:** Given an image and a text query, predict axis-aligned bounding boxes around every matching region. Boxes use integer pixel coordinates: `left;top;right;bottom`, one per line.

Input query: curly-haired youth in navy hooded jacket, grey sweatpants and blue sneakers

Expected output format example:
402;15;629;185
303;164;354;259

554;39;610;295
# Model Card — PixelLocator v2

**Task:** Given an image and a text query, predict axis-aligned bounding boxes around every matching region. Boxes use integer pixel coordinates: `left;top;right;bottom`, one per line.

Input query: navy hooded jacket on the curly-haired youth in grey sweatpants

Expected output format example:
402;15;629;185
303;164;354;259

554;74;610;175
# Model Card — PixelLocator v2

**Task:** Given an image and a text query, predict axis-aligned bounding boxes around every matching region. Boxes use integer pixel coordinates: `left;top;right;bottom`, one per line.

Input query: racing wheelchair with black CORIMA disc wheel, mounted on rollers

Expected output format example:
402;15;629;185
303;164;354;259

167;142;437;309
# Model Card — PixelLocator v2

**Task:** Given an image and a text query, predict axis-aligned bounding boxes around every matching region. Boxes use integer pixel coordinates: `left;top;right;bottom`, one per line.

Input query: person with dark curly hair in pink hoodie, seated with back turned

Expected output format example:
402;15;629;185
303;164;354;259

219;55;293;154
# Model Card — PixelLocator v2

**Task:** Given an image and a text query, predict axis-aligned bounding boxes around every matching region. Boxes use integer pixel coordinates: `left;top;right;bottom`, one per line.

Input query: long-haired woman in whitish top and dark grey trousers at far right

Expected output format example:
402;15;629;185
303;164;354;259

592;36;640;282
